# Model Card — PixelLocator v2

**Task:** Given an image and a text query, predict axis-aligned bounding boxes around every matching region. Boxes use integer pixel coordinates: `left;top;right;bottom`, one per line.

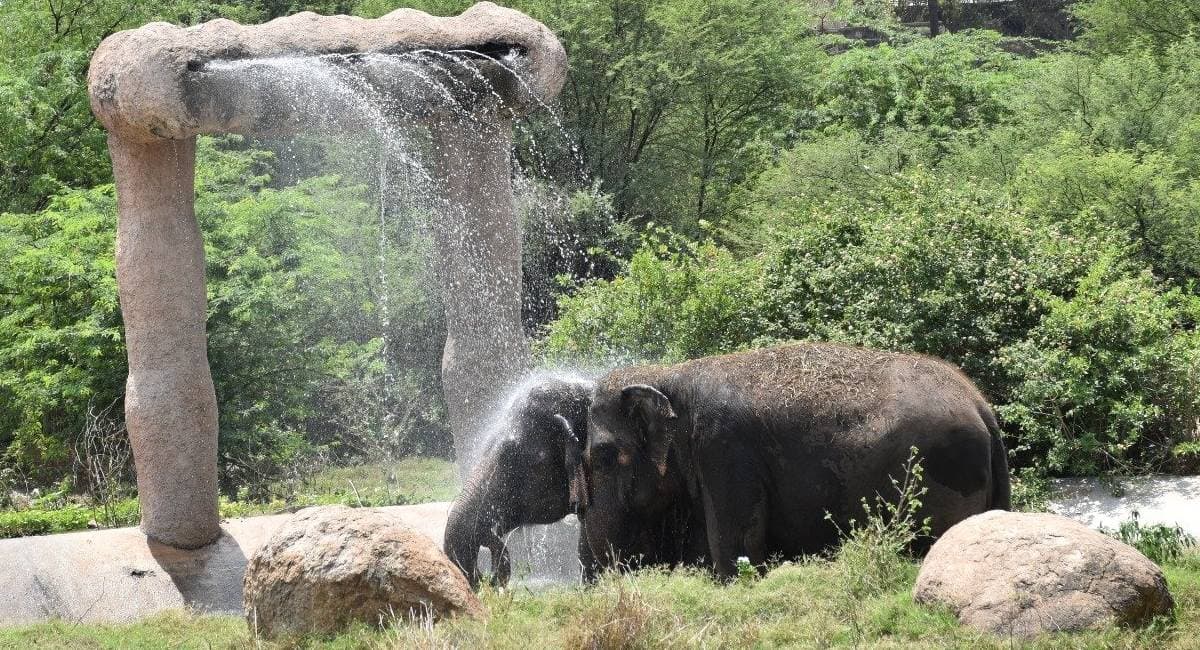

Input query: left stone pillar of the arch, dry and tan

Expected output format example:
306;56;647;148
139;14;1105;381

108;133;221;548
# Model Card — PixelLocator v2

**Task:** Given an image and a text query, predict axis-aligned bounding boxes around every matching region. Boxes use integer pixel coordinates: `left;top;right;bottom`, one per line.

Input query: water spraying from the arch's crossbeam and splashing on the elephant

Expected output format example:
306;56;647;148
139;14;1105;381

200;49;604;583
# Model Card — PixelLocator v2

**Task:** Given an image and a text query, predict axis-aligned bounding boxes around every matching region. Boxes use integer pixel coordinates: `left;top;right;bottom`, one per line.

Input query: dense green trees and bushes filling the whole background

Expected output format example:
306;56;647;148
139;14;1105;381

0;0;1200;520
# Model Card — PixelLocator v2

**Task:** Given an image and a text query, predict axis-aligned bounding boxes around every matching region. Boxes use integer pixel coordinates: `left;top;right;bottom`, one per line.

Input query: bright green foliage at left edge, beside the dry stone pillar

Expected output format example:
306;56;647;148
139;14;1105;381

0;186;125;483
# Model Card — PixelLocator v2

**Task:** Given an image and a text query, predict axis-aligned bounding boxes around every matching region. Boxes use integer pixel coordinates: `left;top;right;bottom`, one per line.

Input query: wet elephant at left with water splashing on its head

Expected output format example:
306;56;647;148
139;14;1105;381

444;375;594;589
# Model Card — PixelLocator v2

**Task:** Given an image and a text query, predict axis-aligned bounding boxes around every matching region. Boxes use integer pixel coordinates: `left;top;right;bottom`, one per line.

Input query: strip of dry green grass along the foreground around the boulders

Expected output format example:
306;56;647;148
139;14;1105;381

0;556;1200;650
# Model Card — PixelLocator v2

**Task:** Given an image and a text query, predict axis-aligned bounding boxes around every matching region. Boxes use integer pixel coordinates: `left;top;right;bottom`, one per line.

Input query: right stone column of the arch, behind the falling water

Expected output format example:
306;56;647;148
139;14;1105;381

430;112;529;473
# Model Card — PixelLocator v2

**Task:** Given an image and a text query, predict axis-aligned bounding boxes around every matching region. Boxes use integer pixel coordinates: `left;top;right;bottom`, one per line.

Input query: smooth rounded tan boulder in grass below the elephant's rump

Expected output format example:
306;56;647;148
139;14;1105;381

913;510;1174;637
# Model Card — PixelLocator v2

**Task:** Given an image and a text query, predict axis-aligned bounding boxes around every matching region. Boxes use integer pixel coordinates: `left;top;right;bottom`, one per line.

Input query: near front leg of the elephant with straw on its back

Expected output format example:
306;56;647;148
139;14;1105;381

700;450;767;579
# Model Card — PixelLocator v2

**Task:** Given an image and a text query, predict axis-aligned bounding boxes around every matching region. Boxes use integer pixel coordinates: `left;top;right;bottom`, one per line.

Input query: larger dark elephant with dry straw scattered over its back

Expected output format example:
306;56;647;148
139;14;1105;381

582;343;1010;579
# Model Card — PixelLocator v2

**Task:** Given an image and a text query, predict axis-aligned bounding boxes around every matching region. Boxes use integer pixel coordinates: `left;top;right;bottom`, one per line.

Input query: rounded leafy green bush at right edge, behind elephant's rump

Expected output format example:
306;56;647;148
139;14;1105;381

998;257;1200;474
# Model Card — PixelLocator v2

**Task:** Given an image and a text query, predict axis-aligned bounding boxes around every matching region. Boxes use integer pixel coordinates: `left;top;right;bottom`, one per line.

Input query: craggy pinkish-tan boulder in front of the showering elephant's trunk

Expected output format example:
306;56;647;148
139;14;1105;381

244;506;484;637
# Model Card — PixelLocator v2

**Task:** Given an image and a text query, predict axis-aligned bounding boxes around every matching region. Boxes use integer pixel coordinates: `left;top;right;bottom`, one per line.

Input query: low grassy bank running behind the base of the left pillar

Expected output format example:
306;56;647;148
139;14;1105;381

0;457;458;538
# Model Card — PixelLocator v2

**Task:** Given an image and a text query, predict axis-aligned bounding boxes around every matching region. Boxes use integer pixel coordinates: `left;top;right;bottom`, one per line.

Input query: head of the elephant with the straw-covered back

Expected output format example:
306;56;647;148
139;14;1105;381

583;381;688;575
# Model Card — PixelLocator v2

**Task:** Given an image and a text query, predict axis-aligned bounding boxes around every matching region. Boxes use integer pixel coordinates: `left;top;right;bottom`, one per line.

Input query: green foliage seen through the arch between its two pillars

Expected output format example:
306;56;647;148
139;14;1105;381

197;138;446;498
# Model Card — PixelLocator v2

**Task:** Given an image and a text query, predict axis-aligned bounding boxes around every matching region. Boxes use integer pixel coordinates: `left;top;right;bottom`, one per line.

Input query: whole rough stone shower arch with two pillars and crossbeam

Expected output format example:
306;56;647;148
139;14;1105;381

88;2;566;548
